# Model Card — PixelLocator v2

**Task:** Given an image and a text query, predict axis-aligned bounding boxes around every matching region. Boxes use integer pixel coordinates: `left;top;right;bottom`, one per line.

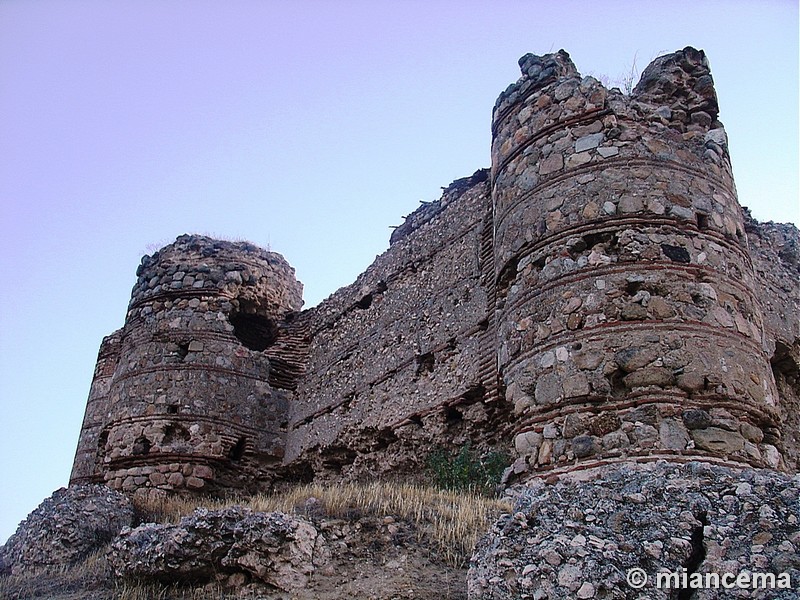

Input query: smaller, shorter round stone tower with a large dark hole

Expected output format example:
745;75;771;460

97;235;302;493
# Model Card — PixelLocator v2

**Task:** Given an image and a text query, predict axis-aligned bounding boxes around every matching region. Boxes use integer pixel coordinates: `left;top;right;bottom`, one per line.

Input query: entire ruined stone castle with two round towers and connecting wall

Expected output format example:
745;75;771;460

71;48;800;495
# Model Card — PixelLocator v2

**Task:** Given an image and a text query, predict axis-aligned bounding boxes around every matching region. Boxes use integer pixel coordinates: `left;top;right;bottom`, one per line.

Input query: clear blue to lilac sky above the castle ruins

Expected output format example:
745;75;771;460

0;0;800;542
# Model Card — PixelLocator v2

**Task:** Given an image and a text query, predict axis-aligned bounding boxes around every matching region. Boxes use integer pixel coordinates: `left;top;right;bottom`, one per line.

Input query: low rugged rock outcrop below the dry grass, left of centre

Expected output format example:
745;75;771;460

110;506;328;591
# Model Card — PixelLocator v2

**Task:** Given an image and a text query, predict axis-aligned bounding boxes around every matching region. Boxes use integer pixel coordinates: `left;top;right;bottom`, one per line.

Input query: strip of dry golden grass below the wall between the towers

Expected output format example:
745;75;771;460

137;481;511;567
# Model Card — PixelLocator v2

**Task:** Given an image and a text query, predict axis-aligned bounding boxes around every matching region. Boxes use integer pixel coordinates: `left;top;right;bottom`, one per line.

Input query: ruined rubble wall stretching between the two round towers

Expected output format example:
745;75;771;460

286;171;501;477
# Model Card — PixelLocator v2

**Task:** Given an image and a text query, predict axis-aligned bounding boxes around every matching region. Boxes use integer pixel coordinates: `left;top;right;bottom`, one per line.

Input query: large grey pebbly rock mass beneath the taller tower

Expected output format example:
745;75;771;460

468;463;800;600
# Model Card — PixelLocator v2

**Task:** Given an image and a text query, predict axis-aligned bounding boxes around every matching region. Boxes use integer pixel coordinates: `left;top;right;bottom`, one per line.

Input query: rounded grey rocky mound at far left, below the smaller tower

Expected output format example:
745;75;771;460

0;485;134;574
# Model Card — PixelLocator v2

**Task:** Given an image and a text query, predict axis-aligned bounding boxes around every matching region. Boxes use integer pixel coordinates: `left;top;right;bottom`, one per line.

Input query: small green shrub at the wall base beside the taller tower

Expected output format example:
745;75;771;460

426;442;510;495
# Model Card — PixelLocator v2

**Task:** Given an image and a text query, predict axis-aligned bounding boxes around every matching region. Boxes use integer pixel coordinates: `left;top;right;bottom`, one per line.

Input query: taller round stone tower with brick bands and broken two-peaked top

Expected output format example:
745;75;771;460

492;48;782;474
